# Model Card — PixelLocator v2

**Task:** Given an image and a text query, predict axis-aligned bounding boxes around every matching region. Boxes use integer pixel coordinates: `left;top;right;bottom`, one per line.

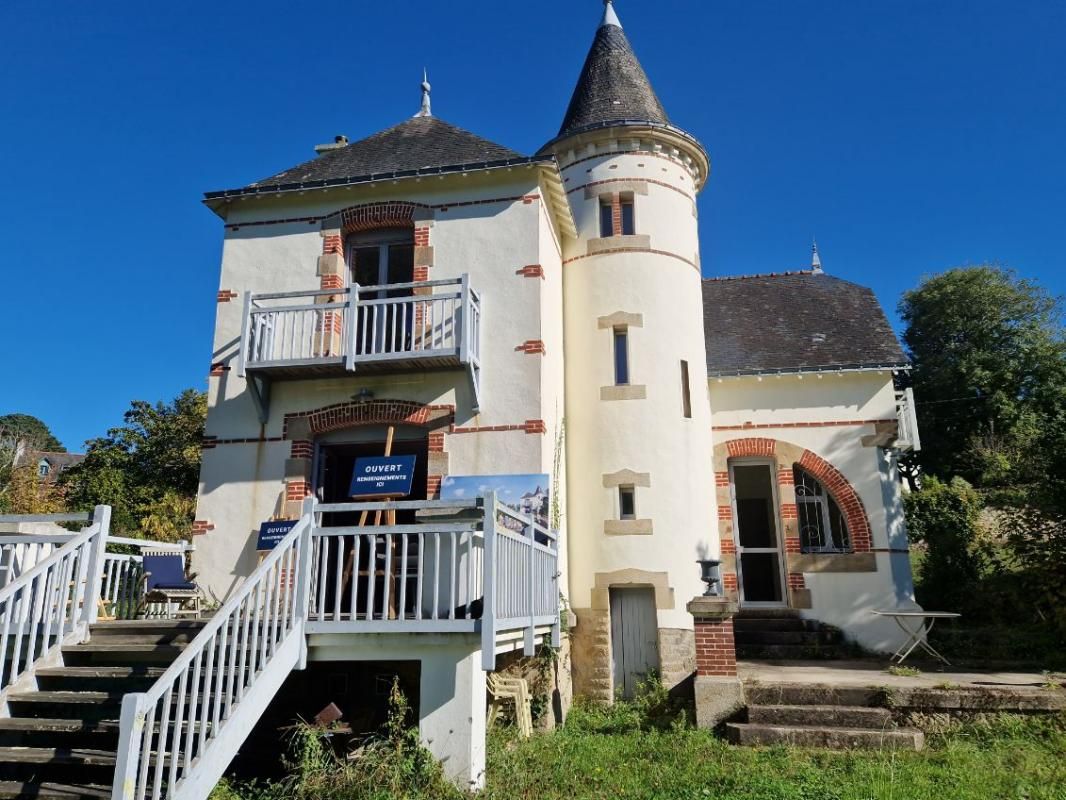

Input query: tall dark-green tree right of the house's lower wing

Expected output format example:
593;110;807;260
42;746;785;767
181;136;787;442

899;266;1066;494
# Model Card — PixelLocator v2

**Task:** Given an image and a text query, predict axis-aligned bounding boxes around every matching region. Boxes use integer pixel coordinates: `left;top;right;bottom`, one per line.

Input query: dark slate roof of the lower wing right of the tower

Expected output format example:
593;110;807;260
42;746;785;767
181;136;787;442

704;271;907;377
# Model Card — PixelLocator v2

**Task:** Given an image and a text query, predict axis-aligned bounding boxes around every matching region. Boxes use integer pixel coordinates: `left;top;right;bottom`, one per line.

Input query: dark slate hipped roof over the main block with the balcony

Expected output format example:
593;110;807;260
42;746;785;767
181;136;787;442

248;116;523;188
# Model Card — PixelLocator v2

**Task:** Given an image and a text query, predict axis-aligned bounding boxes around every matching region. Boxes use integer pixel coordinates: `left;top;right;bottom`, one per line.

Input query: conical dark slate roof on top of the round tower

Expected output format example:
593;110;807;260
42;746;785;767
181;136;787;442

559;15;669;138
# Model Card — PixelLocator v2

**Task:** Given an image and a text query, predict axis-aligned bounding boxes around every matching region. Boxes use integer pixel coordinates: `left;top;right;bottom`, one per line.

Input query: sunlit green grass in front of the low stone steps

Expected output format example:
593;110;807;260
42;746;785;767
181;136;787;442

485;717;1066;800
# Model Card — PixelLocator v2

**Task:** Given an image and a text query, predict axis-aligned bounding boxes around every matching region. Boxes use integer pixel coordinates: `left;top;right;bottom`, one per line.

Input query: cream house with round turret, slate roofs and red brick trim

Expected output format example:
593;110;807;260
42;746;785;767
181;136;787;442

194;0;917;785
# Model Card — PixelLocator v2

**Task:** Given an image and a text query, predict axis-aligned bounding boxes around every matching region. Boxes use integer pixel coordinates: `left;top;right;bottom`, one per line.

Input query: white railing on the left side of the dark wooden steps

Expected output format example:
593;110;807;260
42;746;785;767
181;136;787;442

0;506;111;714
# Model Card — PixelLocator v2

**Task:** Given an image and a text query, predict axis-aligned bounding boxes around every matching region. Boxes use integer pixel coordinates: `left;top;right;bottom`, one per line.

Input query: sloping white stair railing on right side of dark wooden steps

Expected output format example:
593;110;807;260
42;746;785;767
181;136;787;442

112;512;312;800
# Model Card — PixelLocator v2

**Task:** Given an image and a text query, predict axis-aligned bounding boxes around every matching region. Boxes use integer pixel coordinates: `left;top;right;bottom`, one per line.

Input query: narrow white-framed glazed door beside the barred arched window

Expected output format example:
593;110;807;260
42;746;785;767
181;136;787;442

729;461;787;606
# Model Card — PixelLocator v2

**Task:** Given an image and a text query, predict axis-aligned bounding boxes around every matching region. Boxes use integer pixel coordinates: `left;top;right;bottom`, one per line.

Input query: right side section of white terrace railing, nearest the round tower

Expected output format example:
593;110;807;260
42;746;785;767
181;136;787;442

481;493;560;671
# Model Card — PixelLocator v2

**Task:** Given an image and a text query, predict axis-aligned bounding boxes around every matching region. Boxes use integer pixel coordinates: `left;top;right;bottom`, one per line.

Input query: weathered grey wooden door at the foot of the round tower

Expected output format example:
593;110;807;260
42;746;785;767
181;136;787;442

611;589;659;698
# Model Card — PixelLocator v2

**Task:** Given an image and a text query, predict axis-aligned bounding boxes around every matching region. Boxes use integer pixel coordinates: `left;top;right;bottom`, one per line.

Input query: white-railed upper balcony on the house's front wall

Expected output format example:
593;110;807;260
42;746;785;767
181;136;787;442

238;275;481;421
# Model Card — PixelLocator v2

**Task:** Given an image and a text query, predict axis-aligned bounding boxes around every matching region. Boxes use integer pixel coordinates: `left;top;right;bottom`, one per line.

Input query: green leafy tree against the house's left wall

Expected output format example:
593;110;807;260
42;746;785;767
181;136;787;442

62;389;207;541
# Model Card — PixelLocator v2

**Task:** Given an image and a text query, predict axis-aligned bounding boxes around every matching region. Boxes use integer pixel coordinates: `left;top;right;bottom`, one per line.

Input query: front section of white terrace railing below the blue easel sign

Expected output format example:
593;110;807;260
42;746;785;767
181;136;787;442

308;500;484;631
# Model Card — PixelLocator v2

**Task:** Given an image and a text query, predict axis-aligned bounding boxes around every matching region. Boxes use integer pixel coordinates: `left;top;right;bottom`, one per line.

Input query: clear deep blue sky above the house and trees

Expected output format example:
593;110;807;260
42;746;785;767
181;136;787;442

0;0;1066;449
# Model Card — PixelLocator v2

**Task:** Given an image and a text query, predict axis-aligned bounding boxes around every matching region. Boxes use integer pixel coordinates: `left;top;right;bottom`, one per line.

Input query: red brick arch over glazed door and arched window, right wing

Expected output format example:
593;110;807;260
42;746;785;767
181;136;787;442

714;436;873;553
